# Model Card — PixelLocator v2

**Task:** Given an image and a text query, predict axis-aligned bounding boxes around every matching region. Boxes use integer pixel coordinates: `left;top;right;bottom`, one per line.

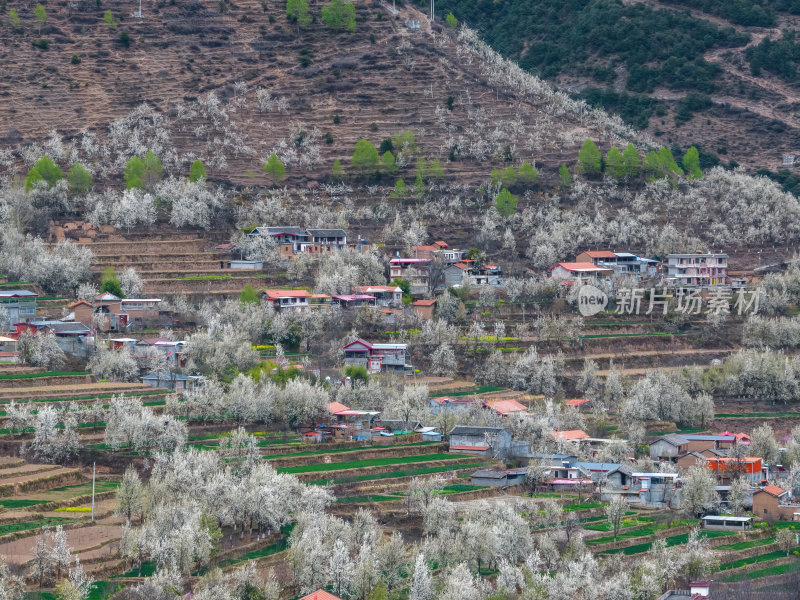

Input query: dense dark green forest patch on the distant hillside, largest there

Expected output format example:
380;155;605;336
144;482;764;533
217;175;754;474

437;0;749;92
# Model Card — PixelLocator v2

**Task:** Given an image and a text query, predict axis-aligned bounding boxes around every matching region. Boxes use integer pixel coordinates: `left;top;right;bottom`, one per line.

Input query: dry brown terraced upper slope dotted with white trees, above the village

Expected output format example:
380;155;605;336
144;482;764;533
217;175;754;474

0;0;633;186
